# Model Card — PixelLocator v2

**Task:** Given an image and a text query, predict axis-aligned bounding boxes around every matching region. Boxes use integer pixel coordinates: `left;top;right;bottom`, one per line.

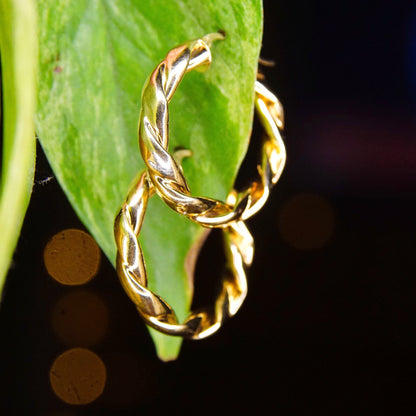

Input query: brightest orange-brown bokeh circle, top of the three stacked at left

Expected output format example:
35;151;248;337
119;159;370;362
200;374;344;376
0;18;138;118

43;229;101;286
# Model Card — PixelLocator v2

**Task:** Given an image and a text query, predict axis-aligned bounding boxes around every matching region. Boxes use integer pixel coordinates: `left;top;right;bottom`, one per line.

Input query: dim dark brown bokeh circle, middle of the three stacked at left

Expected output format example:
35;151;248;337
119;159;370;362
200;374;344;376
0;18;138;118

52;290;109;347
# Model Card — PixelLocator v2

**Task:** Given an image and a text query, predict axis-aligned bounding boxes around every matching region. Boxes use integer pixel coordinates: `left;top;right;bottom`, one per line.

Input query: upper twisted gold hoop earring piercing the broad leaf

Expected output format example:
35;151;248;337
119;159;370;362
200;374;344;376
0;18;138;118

139;33;286;228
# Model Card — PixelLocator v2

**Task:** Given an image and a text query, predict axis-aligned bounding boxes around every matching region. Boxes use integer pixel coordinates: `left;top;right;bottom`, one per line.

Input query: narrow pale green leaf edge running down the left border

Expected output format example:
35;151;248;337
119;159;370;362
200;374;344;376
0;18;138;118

0;0;37;293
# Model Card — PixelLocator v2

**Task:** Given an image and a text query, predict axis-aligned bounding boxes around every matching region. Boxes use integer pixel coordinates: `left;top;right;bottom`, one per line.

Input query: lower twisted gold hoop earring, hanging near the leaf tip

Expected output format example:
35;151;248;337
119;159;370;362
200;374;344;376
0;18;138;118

114;172;254;339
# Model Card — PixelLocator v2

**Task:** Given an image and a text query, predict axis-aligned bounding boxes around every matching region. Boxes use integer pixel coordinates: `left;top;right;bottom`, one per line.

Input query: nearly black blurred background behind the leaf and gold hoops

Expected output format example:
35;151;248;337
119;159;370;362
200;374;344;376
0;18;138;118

0;0;416;415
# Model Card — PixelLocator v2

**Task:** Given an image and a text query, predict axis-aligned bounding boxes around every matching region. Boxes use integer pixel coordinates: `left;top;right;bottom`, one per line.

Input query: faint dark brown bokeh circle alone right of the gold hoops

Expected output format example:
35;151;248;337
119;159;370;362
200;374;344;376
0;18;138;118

278;193;335;250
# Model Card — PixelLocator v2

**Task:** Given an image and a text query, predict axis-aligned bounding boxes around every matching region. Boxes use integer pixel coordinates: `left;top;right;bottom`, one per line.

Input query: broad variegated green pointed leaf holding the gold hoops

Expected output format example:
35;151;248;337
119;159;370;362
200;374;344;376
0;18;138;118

37;0;262;360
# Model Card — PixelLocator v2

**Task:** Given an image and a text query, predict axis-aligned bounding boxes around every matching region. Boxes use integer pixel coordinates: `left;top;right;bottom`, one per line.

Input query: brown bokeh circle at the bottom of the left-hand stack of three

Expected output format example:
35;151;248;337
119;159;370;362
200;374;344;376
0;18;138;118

49;348;107;405
